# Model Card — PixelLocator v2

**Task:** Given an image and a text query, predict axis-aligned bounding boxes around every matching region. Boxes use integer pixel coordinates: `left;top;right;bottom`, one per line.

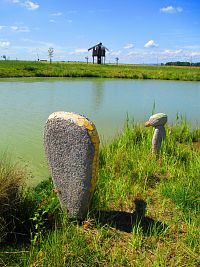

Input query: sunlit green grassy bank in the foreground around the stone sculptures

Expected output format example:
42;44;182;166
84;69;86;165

0;123;200;267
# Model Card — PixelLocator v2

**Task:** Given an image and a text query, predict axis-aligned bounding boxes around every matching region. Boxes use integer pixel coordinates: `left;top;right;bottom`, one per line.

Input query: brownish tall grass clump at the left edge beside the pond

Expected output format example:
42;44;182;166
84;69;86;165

0;154;26;242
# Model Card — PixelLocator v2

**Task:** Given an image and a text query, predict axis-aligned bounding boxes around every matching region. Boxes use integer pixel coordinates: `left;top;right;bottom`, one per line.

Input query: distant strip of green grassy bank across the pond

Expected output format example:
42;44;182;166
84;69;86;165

0;60;200;81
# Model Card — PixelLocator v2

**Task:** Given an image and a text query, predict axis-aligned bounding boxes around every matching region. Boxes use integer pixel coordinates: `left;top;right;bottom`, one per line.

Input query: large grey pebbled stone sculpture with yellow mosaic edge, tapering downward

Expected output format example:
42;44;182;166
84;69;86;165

44;112;99;219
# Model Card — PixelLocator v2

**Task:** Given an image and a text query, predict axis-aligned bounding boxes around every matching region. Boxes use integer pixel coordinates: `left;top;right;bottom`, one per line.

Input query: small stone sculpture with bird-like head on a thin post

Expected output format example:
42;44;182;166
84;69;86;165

145;113;167;154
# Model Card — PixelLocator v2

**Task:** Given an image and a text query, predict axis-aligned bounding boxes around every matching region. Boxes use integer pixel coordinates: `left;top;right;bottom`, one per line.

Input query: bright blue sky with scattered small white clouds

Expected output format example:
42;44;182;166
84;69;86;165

0;0;200;64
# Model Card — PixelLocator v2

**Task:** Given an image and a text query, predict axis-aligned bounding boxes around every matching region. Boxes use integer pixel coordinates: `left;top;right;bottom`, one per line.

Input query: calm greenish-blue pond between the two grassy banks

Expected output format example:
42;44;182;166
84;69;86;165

0;79;200;184
